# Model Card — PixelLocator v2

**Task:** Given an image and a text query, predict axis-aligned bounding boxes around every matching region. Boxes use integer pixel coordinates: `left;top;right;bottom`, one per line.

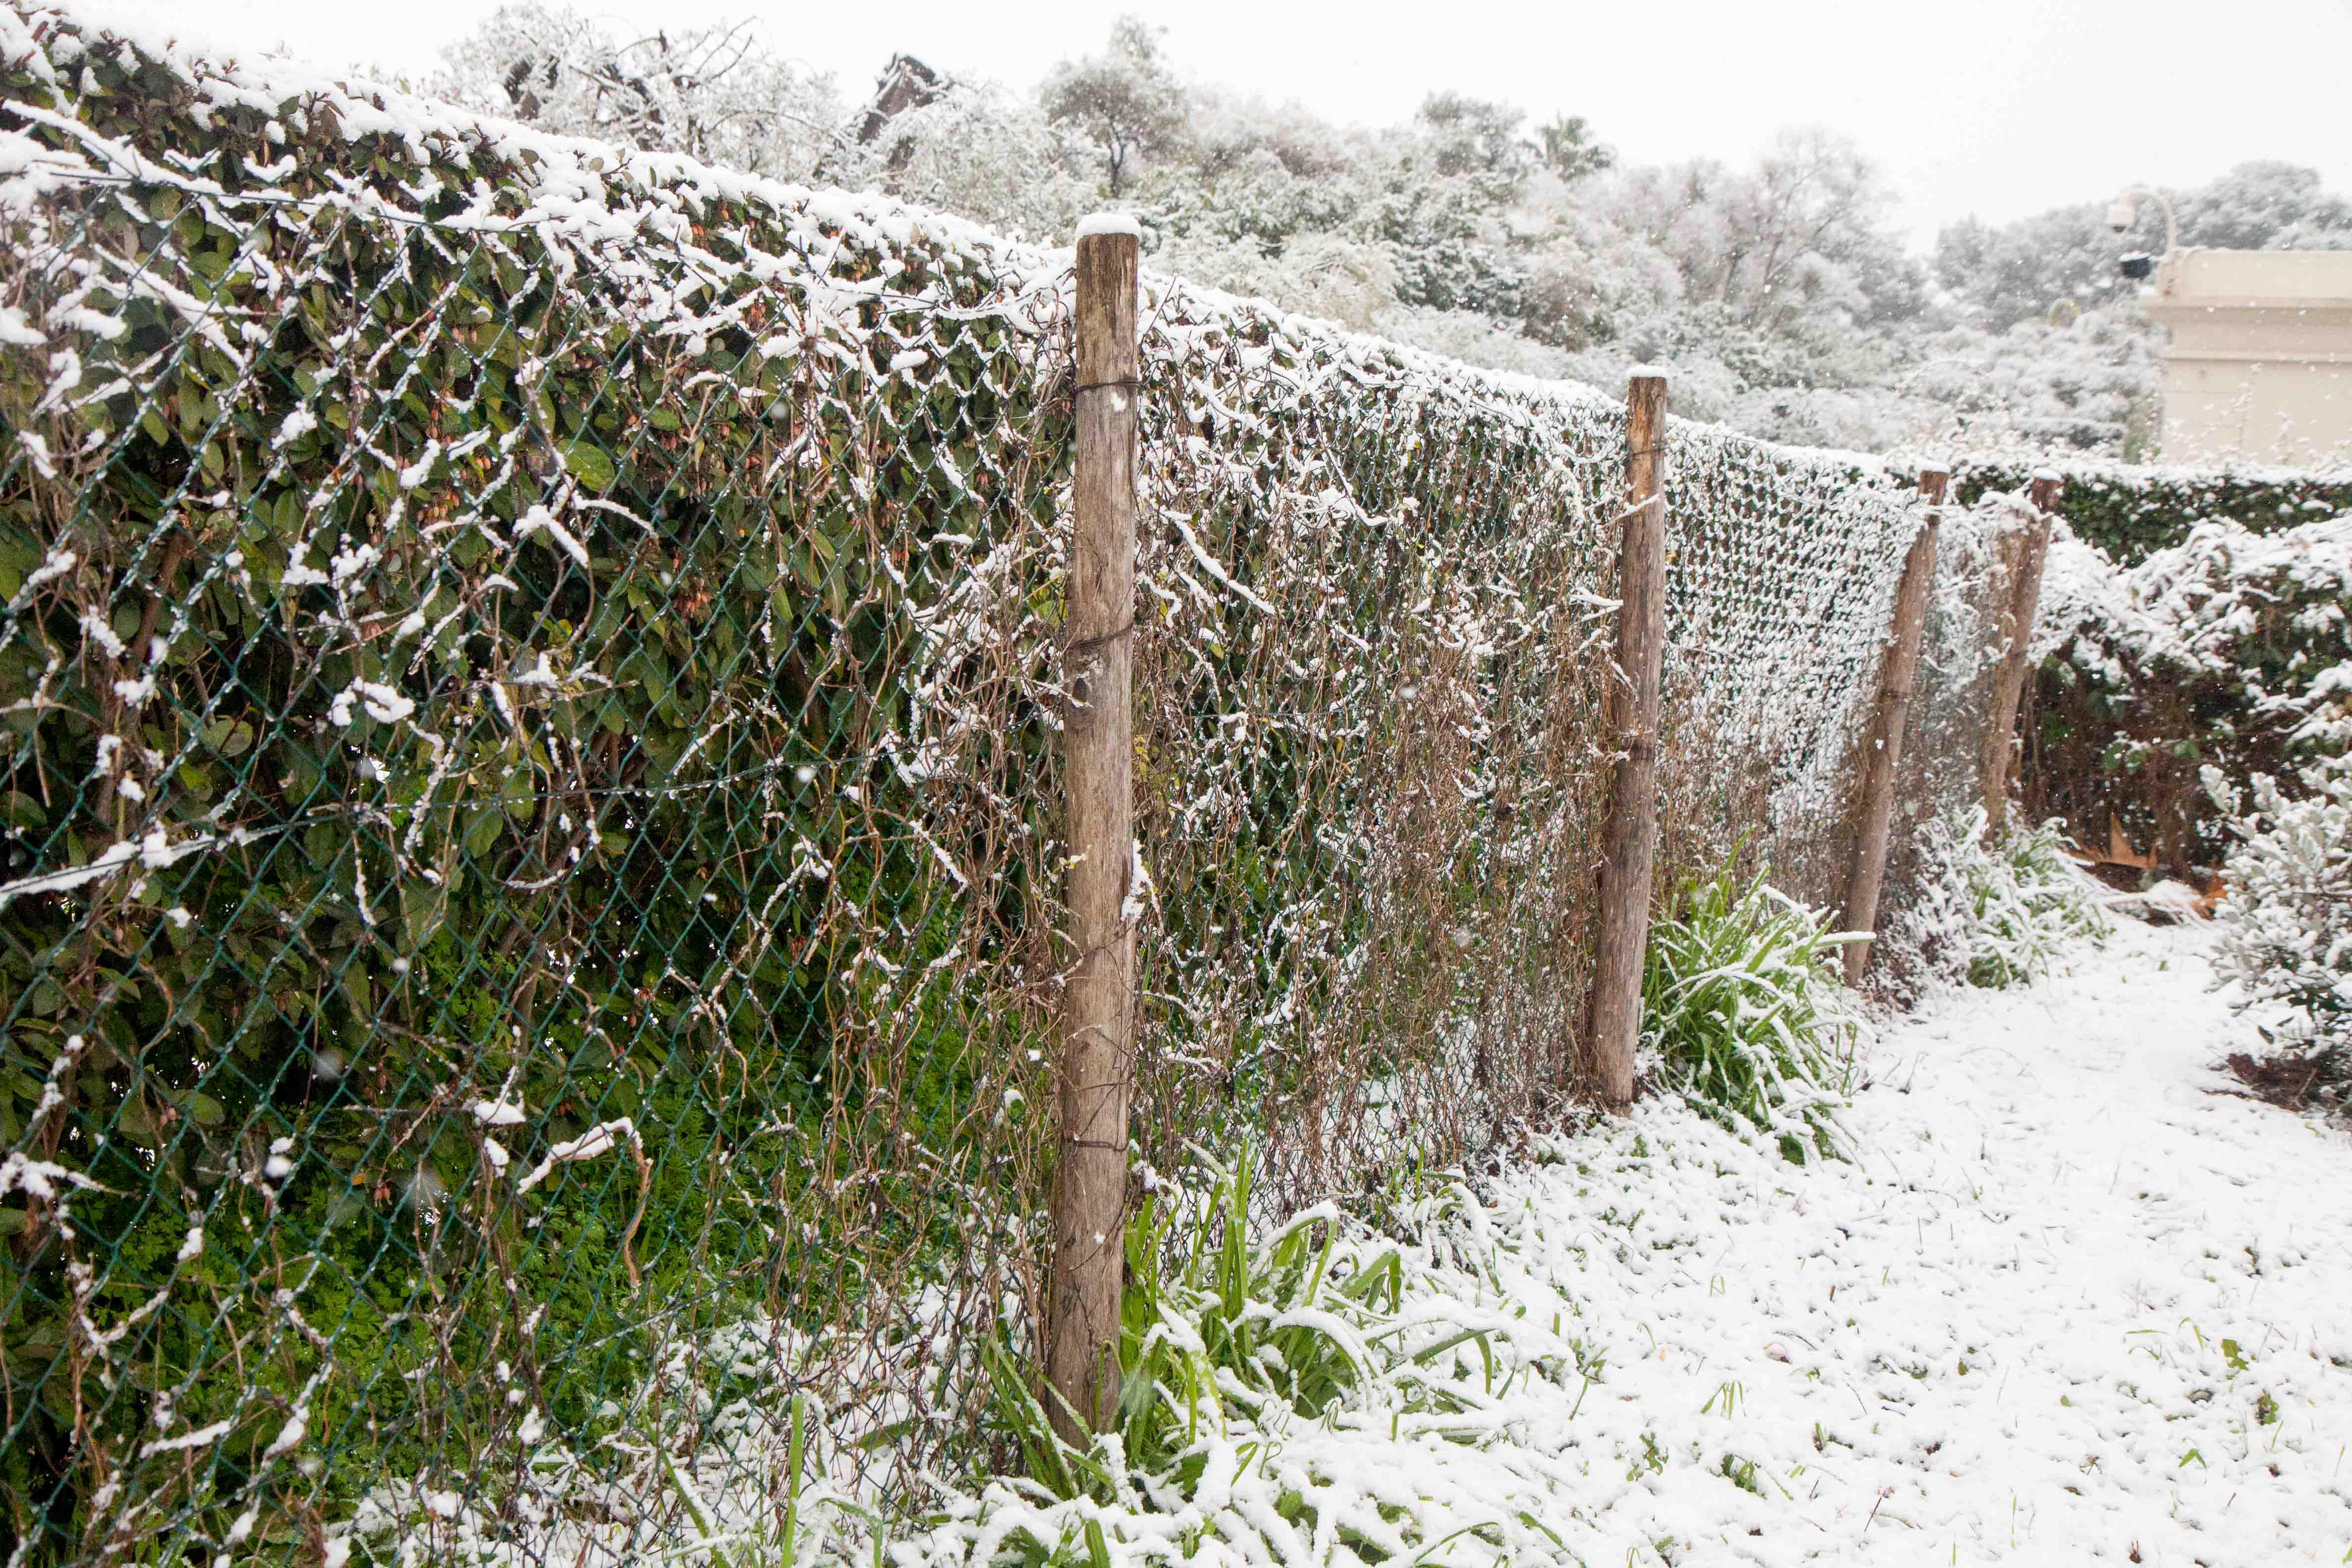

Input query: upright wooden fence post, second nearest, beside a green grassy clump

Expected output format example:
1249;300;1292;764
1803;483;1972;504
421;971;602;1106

1590;374;1665;1110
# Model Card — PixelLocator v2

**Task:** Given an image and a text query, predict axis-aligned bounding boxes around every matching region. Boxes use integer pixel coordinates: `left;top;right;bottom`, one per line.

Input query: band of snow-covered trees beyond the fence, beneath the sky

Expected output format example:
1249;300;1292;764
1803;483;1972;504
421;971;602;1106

431;10;2352;456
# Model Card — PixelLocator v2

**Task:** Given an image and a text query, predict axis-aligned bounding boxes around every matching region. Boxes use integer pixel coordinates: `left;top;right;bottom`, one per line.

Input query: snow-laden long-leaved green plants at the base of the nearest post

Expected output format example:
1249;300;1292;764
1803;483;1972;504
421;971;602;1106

927;1152;1607;1568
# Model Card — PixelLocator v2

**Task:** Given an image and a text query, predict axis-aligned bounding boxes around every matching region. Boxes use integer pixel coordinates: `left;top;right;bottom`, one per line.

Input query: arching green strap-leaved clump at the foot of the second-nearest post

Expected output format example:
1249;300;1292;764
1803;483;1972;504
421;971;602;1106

1642;868;1861;1164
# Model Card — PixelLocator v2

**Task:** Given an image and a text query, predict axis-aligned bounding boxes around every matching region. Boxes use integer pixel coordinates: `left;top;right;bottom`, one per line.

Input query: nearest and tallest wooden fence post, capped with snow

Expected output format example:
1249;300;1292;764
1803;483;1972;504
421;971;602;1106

1044;219;1141;1446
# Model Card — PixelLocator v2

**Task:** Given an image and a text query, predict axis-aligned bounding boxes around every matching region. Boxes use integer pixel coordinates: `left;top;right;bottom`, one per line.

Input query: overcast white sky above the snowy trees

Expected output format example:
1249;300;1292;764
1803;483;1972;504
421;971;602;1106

147;0;2352;247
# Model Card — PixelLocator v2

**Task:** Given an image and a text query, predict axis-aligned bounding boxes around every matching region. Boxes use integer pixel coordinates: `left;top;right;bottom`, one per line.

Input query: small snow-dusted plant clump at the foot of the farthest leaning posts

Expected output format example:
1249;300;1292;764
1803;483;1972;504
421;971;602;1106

1884;806;2110;987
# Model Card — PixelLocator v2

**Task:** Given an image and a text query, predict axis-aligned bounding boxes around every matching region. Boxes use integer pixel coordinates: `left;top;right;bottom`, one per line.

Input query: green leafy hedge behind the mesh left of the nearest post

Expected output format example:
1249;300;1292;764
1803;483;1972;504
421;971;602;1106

0;18;1066;1561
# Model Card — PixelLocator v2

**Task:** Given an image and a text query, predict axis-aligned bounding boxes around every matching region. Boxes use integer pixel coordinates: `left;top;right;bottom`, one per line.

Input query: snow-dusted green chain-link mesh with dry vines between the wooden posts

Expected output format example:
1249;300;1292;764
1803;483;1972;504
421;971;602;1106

0;12;1976;1564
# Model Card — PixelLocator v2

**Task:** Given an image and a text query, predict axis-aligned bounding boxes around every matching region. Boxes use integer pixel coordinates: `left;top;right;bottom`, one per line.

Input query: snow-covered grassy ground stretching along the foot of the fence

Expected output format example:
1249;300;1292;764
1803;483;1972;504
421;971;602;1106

352;924;2352;1568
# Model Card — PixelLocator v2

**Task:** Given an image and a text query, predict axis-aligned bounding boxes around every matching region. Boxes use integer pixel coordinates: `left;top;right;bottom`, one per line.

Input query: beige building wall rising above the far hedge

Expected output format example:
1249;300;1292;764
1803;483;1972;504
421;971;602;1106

2140;249;2352;468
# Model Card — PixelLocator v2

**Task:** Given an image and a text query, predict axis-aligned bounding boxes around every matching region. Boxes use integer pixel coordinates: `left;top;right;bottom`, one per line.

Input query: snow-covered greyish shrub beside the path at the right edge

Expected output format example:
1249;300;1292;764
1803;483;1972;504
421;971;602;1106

2204;759;2352;1105
